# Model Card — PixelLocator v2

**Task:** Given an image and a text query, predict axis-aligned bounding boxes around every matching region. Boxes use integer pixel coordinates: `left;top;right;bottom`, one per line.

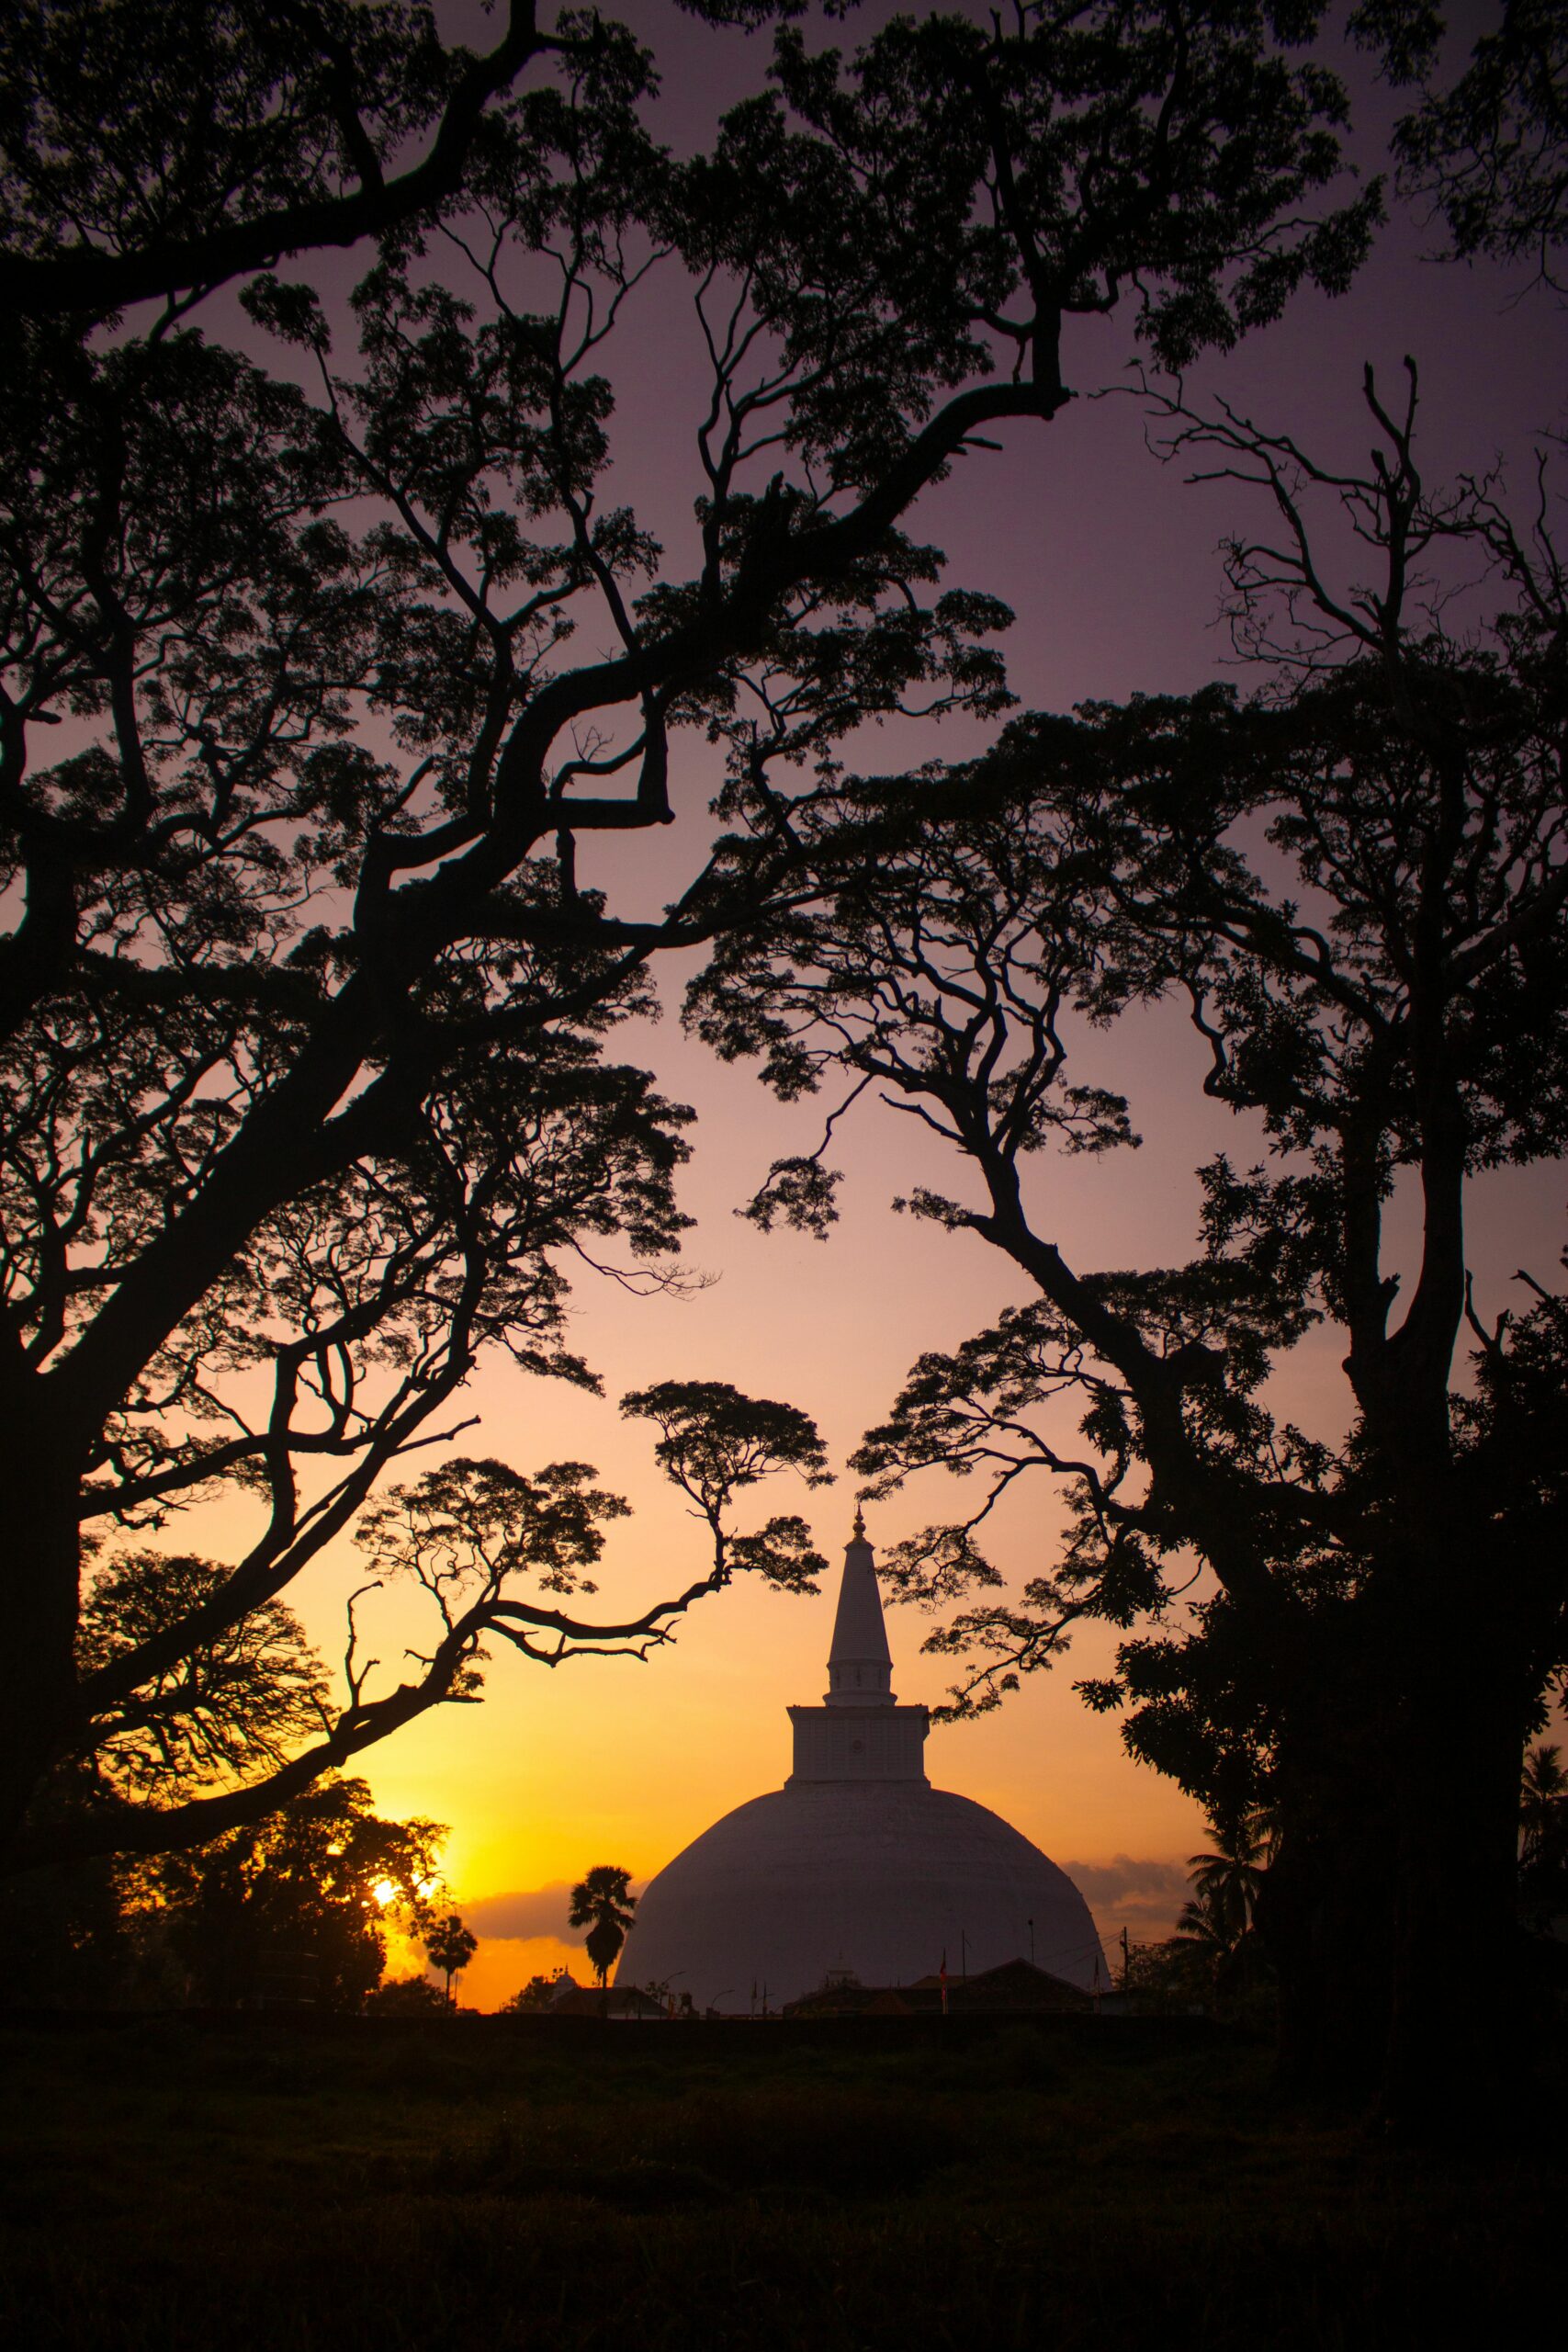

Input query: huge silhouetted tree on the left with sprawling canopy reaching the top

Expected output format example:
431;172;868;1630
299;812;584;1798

0;0;1378;1863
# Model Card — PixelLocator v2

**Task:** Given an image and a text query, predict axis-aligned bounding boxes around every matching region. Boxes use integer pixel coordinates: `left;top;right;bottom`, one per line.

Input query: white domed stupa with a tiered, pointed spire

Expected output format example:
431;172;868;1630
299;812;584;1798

616;1517;1110;2011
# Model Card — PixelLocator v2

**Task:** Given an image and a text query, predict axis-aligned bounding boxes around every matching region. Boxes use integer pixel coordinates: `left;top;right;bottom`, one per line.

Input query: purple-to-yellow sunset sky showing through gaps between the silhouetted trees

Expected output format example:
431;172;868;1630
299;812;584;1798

143;0;1568;2007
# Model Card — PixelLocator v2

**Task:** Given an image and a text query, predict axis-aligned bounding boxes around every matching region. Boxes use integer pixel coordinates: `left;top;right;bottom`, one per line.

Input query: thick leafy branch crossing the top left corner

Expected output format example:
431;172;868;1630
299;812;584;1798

0;0;639;322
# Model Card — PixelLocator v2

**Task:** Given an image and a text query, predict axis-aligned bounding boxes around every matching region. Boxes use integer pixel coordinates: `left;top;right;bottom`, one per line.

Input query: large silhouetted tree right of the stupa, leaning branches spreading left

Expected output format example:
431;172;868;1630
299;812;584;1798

691;374;1568;2121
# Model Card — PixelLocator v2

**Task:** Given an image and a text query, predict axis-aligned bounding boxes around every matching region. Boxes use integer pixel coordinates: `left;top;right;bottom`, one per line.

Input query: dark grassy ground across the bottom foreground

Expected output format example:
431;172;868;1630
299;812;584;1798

0;2018;1568;2352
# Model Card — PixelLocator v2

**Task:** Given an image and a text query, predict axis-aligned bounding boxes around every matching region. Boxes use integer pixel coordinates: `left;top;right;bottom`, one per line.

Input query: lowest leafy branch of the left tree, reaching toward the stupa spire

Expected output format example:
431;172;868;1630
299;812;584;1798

33;1381;823;1858
